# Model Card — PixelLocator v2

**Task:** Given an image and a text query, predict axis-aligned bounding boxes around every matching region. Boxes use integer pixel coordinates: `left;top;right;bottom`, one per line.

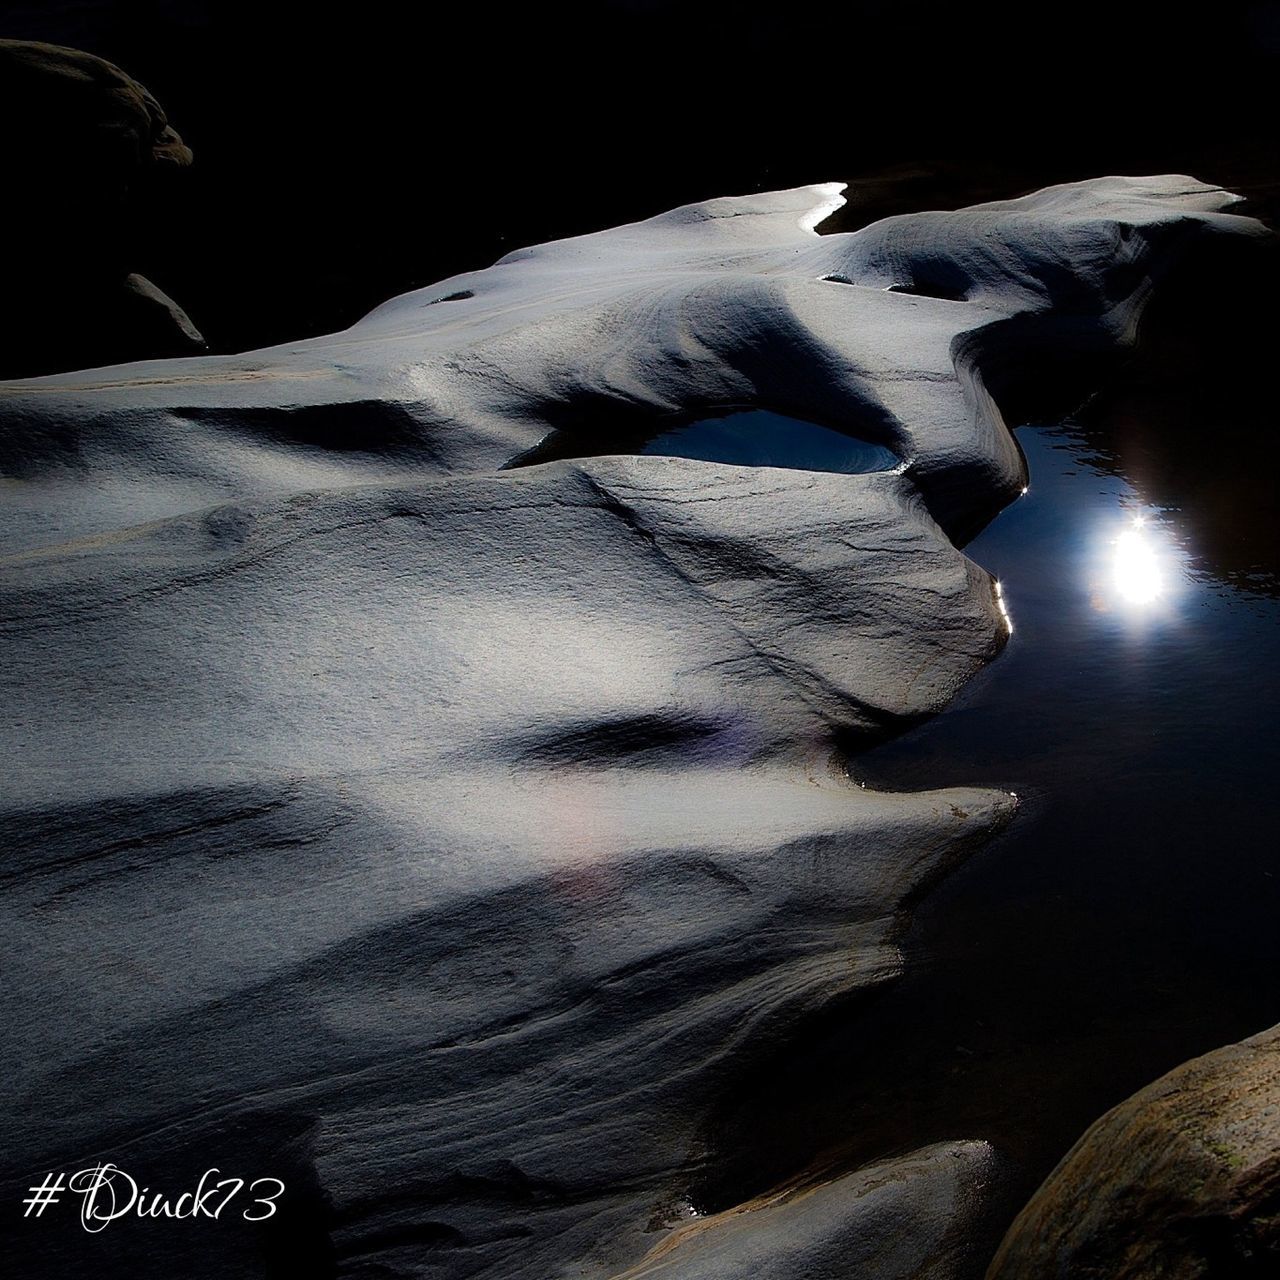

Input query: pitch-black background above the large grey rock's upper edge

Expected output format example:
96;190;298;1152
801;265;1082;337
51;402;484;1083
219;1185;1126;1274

0;0;1280;351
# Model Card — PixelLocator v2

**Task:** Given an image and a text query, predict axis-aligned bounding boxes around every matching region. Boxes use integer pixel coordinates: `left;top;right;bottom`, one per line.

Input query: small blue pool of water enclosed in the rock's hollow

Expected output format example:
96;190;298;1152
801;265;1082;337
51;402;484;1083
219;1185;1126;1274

640;410;899;472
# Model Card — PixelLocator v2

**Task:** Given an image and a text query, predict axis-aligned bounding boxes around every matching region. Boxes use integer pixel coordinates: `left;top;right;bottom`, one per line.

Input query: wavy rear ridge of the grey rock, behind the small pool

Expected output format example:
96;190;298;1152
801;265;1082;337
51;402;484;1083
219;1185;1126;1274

0;177;1263;549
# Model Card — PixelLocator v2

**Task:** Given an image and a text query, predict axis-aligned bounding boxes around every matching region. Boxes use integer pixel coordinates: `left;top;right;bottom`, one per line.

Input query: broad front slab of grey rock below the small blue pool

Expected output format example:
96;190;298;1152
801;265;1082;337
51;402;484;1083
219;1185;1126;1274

4;458;1014;1275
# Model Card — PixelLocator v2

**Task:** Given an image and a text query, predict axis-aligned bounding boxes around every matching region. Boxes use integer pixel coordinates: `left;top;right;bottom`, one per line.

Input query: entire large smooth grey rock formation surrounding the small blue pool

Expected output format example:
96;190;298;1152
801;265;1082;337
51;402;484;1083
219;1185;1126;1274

0;178;1254;1280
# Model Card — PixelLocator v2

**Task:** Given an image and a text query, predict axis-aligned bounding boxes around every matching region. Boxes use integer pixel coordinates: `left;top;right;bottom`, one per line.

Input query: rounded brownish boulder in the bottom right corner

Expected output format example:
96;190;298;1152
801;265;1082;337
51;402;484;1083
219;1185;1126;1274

988;1028;1280;1280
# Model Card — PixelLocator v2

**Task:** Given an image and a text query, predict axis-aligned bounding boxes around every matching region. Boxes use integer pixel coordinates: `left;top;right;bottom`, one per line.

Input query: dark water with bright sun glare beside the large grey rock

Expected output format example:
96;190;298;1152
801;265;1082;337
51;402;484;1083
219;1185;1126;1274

701;420;1280;1259
